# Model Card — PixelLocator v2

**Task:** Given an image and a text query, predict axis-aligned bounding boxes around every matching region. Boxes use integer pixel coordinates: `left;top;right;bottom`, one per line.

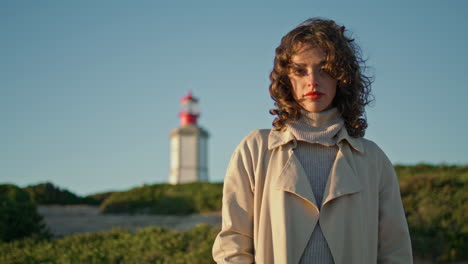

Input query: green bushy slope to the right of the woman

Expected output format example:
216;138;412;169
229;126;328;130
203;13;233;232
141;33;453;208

396;165;468;263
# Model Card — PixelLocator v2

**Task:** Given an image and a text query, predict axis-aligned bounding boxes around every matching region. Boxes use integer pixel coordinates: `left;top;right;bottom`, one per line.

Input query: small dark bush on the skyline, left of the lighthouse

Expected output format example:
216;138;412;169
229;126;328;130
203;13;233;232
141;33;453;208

24;182;99;205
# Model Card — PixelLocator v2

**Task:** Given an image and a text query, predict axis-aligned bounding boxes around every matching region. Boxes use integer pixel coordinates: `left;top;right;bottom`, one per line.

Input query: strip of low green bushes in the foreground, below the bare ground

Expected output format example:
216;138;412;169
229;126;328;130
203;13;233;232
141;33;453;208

0;225;218;264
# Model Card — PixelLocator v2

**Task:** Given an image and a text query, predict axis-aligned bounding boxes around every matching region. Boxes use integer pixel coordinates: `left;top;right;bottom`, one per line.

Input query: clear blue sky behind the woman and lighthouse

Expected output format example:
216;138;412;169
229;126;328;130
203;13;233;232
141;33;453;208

0;0;468;195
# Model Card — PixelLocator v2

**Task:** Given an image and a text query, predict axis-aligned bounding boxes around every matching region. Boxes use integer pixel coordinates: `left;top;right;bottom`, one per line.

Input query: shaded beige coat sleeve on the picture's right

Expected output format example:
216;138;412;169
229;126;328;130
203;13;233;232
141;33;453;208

377;152;413;264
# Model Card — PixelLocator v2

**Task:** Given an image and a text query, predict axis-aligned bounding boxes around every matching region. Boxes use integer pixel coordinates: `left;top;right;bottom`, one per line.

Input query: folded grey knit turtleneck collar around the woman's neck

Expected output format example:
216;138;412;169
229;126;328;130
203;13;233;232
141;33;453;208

286;107;344;146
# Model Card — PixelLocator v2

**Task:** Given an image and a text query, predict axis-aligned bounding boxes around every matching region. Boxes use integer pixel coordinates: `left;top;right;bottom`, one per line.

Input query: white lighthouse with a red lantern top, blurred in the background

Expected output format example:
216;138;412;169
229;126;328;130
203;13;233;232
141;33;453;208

169;92;209;184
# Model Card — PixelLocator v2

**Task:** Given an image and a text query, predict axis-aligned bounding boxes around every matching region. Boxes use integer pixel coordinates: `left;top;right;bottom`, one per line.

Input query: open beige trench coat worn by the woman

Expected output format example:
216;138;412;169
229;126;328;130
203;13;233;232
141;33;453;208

213;129;412;264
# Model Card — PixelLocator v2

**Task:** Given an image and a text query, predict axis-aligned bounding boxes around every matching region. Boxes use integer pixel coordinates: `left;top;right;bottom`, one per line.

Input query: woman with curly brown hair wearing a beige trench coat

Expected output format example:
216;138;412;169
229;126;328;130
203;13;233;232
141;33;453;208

213;18;412;264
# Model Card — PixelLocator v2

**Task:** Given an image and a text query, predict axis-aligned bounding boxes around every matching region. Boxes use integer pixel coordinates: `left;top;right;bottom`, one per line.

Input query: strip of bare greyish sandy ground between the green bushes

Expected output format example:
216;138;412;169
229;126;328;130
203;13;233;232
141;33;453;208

38;205;221;237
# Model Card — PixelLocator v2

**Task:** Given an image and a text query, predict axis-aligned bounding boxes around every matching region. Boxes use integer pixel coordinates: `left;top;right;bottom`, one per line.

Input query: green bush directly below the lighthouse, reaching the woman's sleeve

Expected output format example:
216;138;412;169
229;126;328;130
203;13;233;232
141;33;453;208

101;182;223;215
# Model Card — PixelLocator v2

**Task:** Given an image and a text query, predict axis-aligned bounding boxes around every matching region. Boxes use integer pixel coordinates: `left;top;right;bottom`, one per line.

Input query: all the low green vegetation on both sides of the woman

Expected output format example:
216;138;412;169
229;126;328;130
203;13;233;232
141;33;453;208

0;164;468;264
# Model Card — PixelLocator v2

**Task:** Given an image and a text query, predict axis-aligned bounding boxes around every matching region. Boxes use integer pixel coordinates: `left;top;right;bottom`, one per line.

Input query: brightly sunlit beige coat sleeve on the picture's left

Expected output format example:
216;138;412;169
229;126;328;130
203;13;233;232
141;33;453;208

212;141;254;263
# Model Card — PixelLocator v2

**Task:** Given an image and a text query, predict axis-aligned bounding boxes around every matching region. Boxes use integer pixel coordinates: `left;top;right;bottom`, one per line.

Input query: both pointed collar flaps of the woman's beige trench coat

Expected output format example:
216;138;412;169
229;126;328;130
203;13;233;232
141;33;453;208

268;127;364;154
